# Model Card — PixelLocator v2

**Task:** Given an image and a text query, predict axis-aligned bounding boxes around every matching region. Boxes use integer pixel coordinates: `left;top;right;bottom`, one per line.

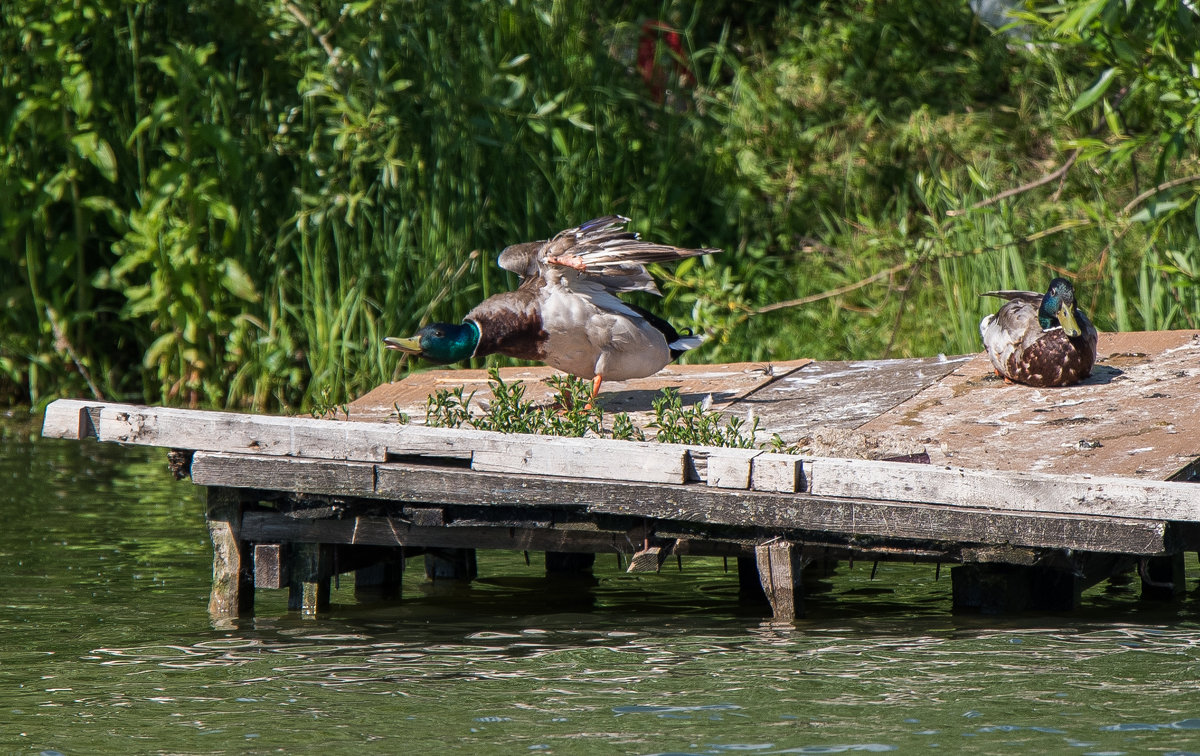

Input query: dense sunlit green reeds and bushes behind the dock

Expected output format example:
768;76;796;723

0;0;1200;410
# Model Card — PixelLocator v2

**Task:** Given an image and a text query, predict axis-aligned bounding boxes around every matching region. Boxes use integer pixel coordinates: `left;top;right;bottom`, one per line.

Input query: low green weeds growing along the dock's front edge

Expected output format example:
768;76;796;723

425;367;758;449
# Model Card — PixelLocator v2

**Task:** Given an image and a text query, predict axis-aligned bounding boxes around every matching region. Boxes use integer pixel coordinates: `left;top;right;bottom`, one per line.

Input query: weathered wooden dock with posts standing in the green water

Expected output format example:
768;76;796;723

43;331;1200;620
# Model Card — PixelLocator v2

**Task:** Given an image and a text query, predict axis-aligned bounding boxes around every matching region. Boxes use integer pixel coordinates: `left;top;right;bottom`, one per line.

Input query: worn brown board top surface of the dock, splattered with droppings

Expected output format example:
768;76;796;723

349;330;1200;480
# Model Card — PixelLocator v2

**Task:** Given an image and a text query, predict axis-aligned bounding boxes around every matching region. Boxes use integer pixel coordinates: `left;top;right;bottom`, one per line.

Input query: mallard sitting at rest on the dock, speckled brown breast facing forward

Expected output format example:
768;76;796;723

979;278;1096;388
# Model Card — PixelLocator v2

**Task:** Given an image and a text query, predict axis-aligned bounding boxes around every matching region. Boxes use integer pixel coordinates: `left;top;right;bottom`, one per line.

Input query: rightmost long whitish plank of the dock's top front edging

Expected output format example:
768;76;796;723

806;458;1200;521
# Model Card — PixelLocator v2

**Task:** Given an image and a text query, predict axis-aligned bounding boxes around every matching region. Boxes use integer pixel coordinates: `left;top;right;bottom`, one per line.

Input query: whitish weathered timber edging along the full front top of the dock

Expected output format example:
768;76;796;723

43;400;1200;522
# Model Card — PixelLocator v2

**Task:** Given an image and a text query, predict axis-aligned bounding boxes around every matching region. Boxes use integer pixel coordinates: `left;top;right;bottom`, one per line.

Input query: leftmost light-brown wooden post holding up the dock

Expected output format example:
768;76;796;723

205;486;254;622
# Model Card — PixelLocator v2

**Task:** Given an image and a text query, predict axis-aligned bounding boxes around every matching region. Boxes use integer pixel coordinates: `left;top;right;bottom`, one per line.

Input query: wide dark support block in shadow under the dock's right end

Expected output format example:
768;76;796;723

950;563;1081;614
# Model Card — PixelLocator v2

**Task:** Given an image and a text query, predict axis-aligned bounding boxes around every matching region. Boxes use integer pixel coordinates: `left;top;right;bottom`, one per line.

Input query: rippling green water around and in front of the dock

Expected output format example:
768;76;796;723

0;419;1200;755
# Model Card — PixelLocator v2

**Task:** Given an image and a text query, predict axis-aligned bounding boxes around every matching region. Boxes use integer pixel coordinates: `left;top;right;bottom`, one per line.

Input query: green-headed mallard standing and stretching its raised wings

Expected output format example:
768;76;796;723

383;215;720;398
